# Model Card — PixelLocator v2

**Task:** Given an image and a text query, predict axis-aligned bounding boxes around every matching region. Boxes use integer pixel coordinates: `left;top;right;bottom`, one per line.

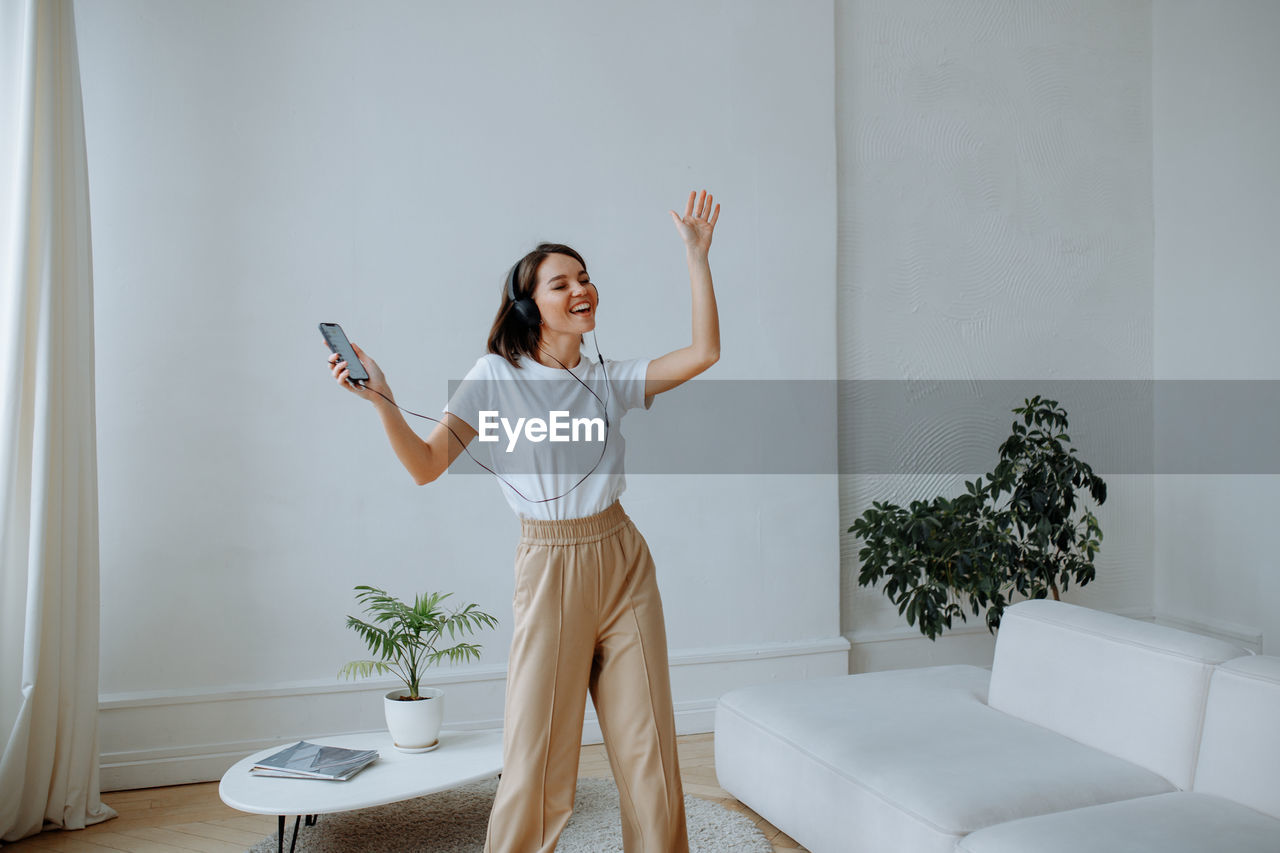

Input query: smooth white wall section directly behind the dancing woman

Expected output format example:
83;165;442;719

77;0;846;789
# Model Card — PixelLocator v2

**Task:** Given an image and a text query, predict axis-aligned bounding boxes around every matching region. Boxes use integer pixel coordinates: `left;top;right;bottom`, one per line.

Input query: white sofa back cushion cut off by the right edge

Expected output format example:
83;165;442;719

1193;656;1280;819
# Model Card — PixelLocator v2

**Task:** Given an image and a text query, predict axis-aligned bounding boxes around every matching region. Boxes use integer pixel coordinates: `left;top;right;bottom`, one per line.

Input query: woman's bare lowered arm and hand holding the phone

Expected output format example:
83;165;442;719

329;343;476;485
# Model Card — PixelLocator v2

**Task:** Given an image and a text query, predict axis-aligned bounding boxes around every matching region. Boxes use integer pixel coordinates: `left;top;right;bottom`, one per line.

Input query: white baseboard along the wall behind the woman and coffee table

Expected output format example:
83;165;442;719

99;637;849;792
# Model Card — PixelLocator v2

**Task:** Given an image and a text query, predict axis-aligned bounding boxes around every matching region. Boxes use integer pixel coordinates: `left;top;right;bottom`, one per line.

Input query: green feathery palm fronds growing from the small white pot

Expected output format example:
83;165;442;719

338;587;498;701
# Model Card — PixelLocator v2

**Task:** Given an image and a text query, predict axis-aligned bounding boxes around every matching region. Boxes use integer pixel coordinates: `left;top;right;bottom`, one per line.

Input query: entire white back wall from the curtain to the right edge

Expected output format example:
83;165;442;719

77;0;1280;788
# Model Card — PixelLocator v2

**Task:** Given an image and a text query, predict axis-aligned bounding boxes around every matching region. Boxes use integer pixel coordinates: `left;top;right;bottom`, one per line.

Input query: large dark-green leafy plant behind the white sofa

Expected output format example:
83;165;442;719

849;396;1107;639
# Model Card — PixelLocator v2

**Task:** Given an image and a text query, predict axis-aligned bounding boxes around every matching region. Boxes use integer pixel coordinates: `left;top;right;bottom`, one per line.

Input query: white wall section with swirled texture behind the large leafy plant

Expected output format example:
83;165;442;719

836;0;1153;671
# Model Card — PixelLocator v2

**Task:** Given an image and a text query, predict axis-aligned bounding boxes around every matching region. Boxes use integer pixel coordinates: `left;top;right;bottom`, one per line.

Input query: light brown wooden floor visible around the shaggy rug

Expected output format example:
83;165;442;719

3;734;804;853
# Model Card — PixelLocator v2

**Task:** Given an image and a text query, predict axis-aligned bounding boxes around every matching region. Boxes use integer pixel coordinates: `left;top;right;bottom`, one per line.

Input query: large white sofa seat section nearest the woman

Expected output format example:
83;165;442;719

716;666;1174;853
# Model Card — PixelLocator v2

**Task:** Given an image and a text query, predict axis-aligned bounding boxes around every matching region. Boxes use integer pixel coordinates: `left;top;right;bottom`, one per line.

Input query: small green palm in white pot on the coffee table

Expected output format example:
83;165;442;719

338;587;498;752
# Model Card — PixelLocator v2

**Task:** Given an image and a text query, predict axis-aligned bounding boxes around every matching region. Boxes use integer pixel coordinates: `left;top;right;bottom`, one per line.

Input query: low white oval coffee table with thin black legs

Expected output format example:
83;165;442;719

218;730;502;852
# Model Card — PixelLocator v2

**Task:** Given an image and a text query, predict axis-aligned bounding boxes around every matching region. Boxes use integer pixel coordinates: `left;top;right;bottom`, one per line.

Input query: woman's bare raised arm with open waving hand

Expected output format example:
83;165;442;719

644;190;719;397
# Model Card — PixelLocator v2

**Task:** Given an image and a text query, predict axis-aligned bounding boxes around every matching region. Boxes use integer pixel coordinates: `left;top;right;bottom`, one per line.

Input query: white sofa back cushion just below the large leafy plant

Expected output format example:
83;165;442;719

989;599;1245;790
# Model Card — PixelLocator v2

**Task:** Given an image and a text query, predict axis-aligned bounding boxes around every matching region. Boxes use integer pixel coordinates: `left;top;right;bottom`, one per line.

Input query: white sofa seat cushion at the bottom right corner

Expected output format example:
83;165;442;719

956;792;1280;853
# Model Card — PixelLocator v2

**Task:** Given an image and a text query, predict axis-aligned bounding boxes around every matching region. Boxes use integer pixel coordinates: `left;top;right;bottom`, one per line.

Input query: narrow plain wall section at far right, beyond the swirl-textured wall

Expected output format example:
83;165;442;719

1152;0;1280;654
